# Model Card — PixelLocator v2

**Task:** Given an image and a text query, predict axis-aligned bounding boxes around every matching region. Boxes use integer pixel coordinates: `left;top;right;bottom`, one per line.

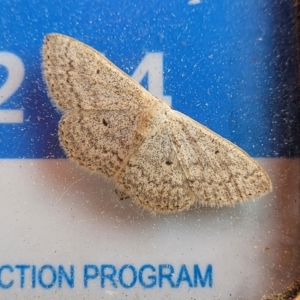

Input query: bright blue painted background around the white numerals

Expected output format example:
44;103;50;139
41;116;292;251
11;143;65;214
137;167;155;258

0;0;300;158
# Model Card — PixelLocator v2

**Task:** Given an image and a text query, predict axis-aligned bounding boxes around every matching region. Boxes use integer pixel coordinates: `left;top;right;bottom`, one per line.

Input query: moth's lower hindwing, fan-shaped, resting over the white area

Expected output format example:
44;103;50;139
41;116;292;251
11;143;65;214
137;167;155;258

117;117;194;212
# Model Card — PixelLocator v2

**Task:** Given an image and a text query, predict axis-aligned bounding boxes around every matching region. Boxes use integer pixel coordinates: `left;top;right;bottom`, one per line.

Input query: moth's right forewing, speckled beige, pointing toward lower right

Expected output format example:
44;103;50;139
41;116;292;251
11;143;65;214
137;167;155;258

168;111;272;207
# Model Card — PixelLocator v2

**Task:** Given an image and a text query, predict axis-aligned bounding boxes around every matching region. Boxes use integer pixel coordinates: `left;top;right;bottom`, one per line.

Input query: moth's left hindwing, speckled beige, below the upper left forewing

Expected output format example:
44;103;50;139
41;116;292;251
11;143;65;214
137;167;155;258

59;110;145;178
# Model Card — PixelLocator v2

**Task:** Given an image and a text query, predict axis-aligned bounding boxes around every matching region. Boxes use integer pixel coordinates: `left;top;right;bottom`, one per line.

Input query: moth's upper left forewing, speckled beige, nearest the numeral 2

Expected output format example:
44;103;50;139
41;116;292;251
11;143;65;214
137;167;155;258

43;34;158;110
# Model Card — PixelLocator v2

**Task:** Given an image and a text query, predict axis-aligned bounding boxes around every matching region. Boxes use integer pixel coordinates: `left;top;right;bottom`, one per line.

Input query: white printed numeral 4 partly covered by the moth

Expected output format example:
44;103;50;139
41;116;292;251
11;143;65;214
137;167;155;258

132;52;172;105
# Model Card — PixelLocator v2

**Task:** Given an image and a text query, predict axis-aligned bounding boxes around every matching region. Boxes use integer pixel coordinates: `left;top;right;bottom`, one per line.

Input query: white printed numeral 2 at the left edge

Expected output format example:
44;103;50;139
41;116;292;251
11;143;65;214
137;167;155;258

0;52;25;123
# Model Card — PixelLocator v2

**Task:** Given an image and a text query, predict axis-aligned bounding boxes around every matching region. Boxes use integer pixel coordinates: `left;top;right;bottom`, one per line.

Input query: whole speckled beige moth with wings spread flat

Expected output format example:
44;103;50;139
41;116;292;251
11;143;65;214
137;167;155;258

42;34;272;213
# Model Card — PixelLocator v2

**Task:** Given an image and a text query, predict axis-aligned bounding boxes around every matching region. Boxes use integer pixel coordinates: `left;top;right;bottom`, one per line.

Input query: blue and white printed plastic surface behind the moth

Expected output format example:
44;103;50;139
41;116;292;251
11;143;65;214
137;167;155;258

0;0;300;300
